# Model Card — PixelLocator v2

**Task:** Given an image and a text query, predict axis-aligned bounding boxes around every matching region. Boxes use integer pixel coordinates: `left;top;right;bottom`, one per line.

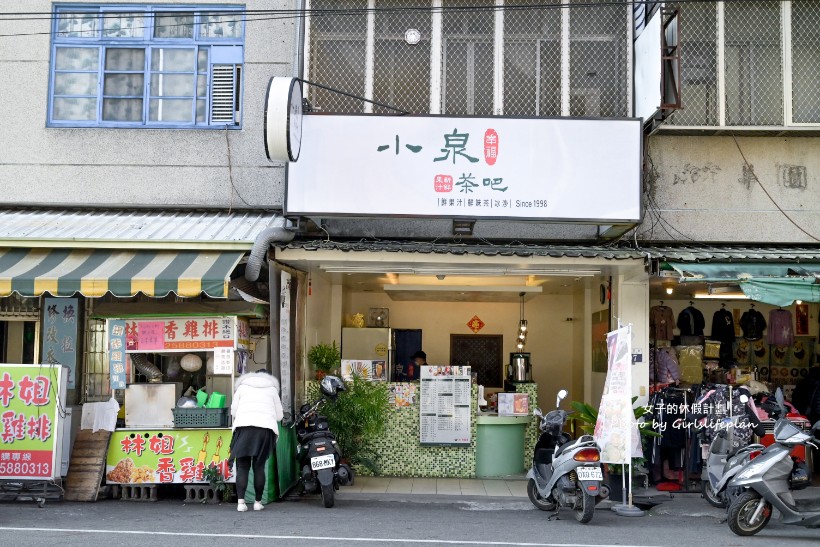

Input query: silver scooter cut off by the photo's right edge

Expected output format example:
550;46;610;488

728;388;820;536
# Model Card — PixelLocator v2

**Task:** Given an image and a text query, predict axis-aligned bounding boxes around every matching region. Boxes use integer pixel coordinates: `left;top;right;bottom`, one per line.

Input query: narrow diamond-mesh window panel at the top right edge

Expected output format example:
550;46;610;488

791;0;820;123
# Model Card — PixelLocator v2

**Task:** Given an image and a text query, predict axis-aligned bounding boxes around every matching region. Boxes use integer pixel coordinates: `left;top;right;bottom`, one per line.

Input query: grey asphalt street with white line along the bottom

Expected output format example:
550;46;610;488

0;490;820;547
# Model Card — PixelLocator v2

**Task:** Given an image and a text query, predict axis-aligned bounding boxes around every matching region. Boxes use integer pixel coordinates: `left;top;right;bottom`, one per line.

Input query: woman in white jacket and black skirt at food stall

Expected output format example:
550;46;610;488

230;369;284;512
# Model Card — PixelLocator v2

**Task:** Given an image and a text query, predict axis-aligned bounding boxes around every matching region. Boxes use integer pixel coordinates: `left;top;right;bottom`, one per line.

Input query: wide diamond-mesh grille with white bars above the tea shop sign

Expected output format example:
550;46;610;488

307;0;631;117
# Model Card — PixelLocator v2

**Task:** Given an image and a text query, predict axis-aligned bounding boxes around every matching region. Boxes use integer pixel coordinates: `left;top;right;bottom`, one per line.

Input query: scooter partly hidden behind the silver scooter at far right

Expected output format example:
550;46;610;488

701;395;766;509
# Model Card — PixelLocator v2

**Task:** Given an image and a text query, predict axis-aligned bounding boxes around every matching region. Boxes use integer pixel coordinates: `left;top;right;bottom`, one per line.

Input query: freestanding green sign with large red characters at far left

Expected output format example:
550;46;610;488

0;364;67;480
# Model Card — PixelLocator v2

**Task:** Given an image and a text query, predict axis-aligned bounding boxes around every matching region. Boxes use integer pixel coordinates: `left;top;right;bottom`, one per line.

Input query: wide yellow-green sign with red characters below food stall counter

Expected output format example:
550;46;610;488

105;429;236;484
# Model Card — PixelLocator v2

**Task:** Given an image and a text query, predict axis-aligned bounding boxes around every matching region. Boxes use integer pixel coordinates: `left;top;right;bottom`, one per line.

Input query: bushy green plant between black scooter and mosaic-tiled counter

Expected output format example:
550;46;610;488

308;374;390;474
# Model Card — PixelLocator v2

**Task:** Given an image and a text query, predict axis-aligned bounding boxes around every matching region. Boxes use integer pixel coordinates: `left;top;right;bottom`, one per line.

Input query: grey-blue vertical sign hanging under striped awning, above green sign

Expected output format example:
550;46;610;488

41;298;79;389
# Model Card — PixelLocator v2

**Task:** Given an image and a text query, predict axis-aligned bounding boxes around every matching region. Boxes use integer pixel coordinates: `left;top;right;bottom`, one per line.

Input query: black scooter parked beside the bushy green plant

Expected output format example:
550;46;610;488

292;376;353;507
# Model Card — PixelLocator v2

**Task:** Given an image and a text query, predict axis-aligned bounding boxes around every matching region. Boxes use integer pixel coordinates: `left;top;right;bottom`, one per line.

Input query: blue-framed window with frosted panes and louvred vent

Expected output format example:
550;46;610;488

48;4;245;129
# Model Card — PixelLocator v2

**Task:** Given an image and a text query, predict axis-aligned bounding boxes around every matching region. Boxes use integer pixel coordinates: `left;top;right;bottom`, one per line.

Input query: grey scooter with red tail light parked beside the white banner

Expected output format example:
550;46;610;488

527;389;608;524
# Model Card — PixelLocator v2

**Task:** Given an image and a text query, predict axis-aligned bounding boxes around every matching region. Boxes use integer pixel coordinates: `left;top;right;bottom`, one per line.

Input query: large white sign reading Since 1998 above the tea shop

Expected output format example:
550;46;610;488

285;115;641;224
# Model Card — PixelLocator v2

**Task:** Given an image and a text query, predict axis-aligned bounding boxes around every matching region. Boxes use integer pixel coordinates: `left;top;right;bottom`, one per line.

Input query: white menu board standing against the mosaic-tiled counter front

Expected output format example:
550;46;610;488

419;365;471;446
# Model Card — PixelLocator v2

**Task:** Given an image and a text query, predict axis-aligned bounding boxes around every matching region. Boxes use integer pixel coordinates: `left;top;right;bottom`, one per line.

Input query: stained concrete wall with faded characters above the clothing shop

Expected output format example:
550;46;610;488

639;136;820;244
